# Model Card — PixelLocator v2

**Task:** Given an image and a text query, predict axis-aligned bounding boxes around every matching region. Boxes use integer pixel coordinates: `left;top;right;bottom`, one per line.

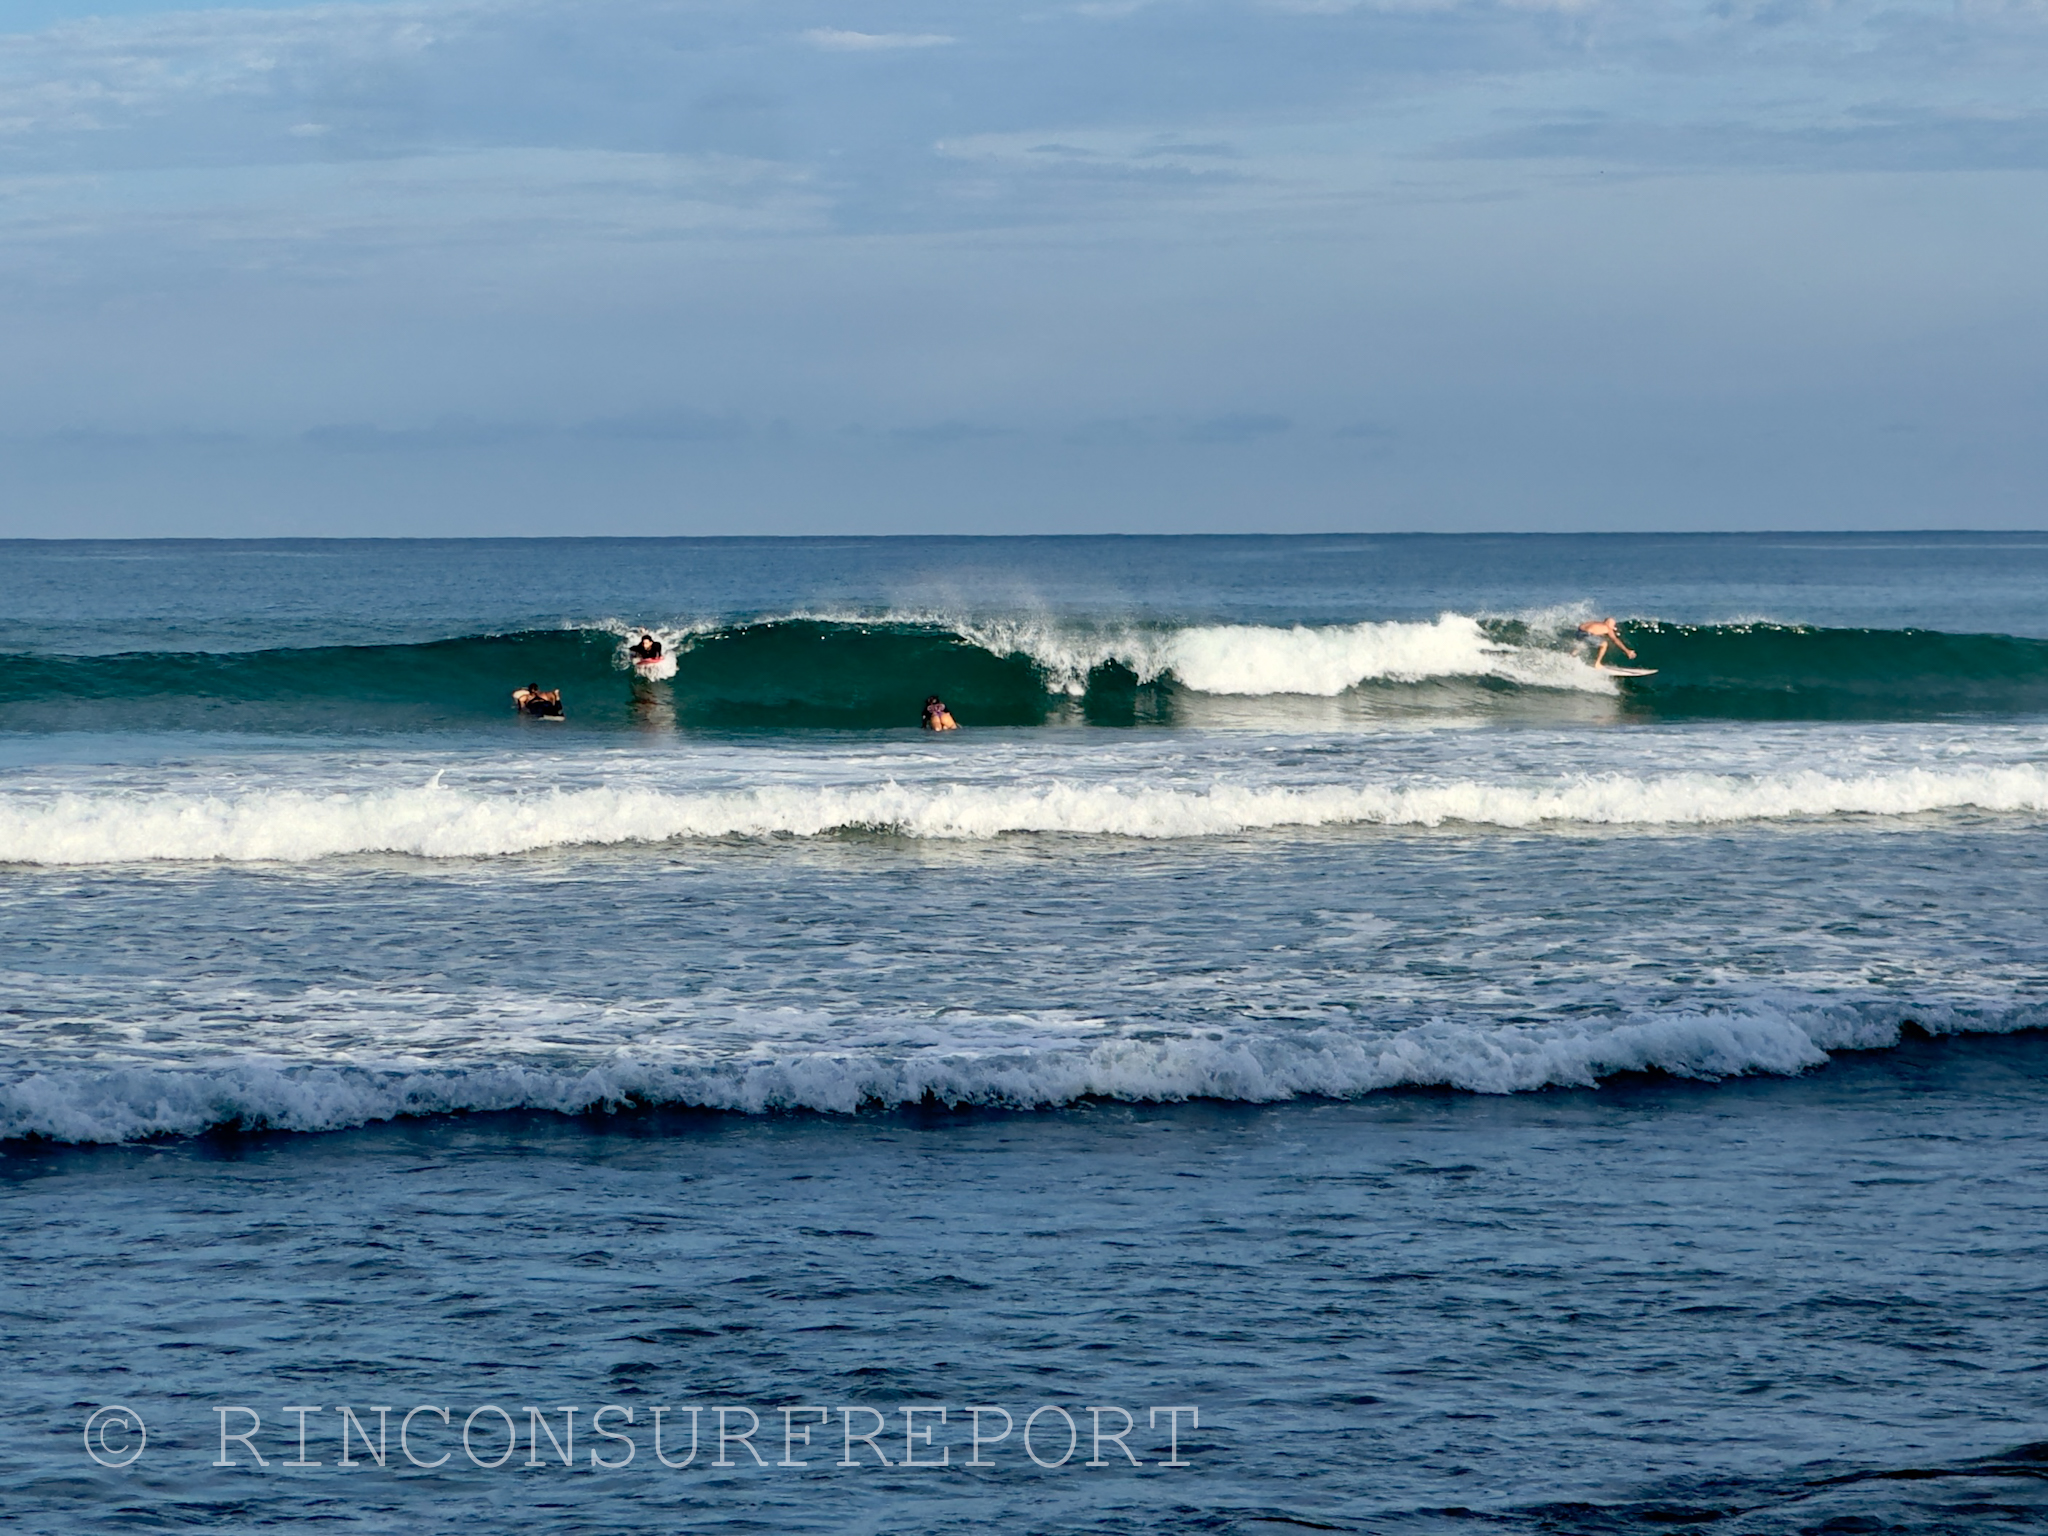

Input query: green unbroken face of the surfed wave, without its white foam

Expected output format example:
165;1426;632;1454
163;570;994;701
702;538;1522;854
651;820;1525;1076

12;618;2048;731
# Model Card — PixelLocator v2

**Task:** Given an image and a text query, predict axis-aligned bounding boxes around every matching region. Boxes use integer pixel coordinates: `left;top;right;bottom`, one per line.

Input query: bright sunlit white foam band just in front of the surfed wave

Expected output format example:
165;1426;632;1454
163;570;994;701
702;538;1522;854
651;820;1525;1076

0;764;2048;864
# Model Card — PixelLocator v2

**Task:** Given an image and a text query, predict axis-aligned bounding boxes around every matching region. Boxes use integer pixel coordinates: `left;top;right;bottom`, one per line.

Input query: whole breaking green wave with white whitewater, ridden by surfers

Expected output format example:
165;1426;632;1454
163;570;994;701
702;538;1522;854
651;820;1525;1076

12;614;2048;731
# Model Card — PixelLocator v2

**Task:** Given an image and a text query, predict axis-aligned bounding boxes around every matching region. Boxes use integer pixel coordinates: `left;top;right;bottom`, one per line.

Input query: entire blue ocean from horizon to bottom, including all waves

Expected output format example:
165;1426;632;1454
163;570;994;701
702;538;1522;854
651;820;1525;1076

0;535;2048;1534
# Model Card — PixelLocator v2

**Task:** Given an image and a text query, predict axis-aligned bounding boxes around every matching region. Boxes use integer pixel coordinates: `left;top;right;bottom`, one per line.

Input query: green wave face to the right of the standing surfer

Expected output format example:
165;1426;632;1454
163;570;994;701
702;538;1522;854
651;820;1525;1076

1610;625;2048;721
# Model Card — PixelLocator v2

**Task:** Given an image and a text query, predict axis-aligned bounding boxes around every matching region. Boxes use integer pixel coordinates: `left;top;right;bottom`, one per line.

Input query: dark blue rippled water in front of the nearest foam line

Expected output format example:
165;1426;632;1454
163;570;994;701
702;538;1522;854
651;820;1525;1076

12;1040;2048;1532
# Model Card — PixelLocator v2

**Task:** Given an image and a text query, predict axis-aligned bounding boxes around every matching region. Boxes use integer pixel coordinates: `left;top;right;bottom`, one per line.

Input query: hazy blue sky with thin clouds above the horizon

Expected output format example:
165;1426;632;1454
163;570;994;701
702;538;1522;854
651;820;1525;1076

0;0;2048;537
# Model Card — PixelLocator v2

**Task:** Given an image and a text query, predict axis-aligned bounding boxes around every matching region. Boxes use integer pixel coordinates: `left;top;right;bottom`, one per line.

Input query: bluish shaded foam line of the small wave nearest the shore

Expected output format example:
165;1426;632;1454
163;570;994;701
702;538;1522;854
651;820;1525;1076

0;1008;2040;1143
